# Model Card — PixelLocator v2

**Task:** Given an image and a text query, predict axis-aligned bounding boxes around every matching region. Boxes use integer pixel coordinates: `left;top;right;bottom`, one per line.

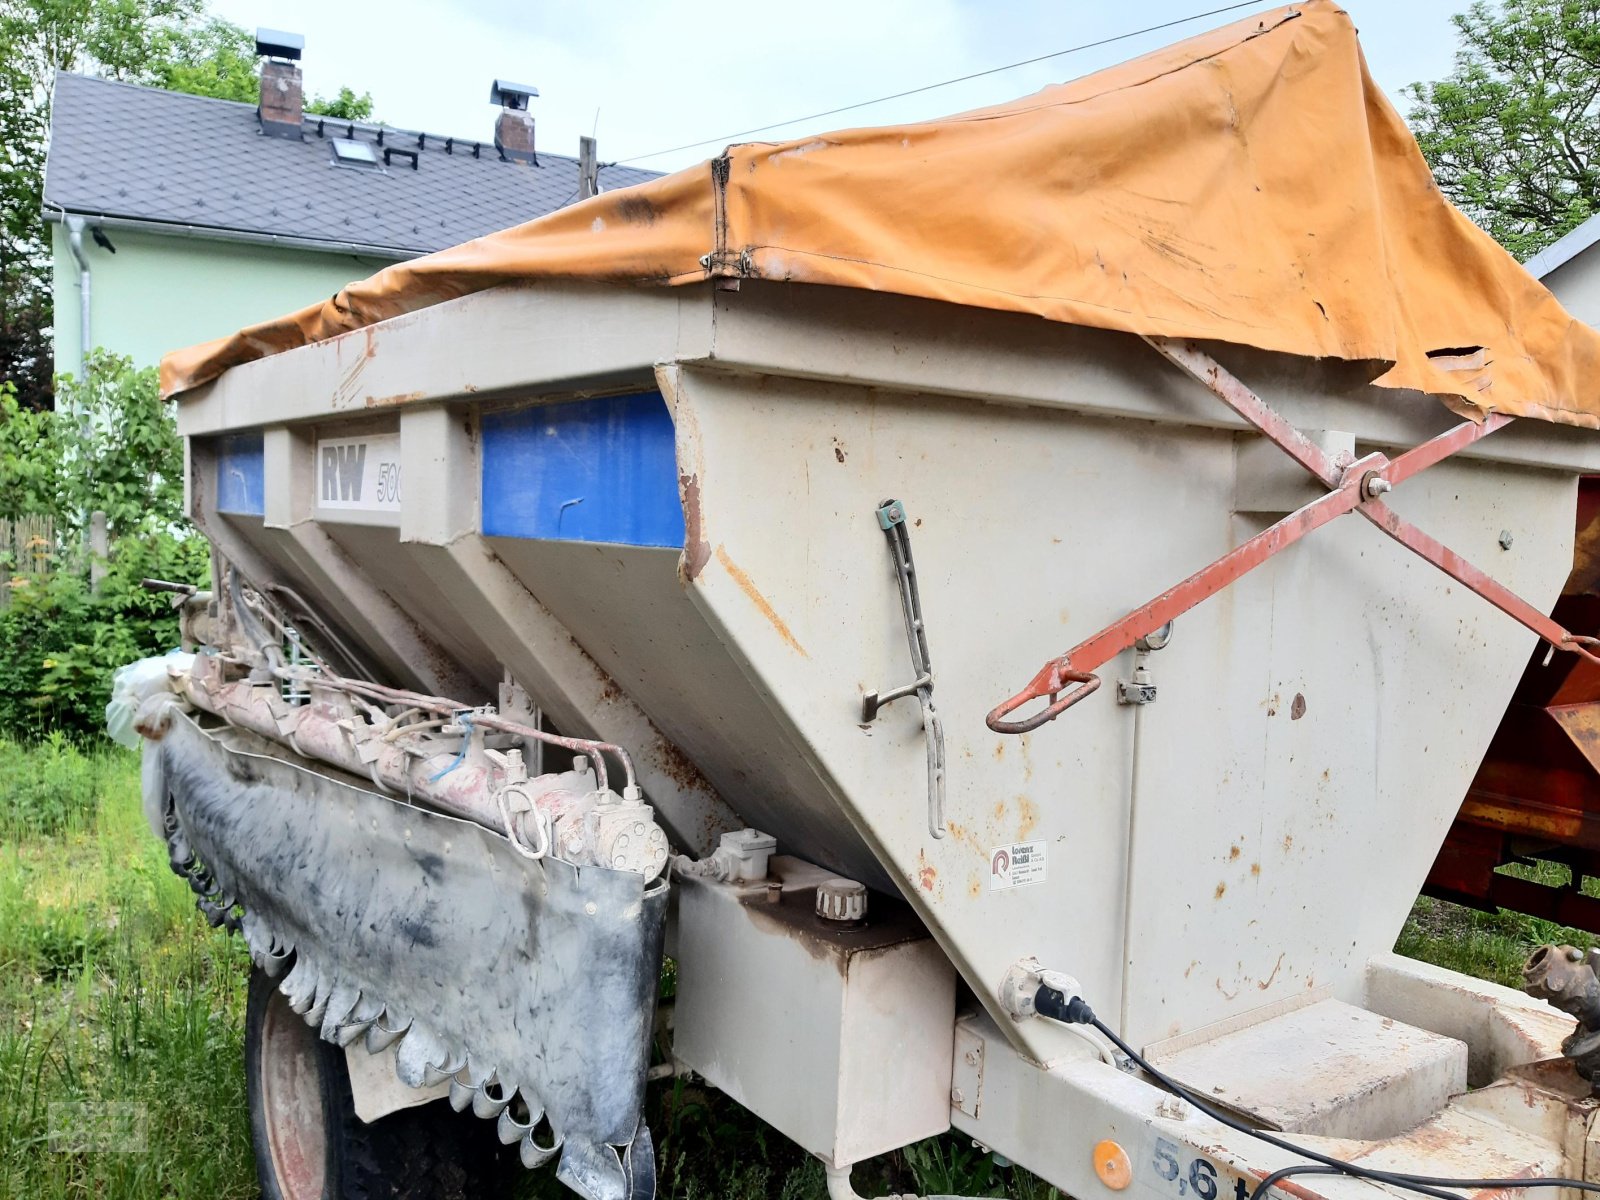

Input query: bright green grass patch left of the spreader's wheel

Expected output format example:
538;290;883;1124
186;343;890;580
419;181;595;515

0;738;256;1200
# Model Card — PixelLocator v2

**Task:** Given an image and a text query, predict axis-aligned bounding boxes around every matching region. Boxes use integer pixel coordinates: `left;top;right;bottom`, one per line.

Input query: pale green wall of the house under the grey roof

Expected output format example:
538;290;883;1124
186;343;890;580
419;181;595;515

51;221;398;374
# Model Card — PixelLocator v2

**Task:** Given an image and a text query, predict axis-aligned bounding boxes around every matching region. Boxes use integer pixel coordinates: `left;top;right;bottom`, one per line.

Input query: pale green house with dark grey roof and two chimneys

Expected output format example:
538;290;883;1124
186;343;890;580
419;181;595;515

45;32;654;373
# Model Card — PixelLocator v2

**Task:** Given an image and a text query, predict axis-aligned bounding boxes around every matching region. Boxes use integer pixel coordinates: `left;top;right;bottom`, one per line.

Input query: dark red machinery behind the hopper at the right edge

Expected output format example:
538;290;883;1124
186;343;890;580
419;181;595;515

1422;475;1600;933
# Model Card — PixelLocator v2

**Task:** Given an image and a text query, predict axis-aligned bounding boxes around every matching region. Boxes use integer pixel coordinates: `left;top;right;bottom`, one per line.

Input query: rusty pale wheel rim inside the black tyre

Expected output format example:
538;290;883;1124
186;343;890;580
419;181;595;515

256;990;328;1200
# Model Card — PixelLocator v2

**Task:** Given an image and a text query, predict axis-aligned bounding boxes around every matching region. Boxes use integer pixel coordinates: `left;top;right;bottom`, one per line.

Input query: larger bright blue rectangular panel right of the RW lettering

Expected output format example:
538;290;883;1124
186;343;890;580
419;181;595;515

483;392;683;549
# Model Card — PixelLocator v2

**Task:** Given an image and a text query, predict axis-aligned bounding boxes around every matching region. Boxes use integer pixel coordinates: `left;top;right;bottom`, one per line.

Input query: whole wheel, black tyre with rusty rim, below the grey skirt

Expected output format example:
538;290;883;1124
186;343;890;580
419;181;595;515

245;966;520;1200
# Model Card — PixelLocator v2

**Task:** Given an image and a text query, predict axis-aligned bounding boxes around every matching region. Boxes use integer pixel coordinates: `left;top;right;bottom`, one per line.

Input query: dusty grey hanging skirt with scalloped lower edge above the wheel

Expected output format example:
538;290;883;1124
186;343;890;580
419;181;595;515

144;714;667;1200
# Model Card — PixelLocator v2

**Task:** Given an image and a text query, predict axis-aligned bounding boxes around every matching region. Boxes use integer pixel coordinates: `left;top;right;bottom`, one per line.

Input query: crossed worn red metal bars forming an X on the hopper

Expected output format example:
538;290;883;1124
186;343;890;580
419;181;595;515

987;338;1600;733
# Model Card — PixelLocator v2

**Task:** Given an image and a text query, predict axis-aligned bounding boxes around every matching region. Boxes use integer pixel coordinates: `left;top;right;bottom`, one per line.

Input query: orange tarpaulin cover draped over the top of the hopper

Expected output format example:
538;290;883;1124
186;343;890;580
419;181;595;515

162;0;1600;427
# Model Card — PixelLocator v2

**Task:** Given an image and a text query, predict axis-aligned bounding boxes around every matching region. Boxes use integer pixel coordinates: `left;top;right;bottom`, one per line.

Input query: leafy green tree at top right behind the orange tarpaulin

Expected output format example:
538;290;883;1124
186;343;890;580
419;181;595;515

1406;0;1600;258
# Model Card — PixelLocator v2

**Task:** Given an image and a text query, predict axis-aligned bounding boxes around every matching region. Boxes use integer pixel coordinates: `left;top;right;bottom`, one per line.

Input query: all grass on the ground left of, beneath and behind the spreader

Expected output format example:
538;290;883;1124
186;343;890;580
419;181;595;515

0;741;1595;1200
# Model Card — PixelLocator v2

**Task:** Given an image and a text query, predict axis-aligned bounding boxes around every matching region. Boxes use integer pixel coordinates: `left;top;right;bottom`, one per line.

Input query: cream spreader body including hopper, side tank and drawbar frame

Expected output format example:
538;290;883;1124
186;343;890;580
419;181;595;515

168;282;1600;1200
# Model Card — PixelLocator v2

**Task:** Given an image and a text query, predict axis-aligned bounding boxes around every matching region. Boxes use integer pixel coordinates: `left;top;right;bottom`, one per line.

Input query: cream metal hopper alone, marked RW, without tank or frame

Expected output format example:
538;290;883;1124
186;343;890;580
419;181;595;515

179;272;1600;1059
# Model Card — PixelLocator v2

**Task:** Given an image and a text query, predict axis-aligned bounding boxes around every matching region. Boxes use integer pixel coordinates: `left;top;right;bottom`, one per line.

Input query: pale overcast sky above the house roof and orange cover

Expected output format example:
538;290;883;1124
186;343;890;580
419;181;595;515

213;0;1467;182
